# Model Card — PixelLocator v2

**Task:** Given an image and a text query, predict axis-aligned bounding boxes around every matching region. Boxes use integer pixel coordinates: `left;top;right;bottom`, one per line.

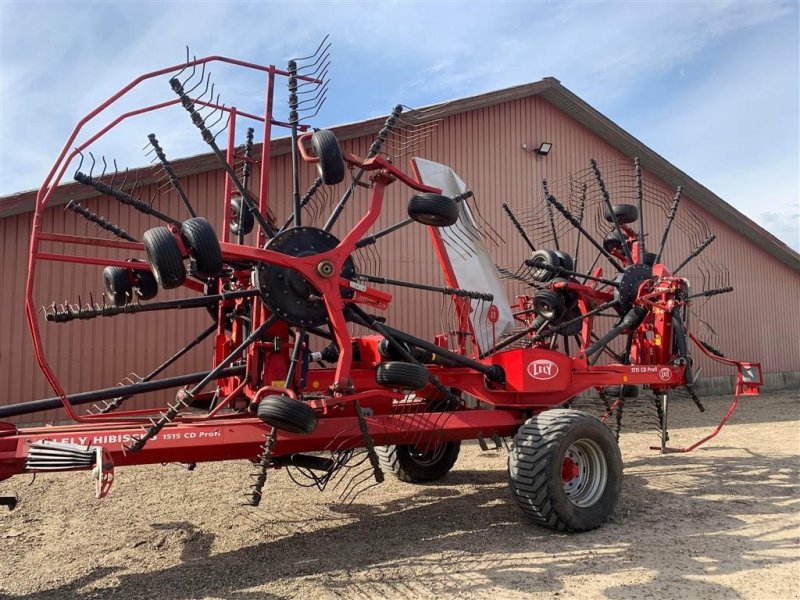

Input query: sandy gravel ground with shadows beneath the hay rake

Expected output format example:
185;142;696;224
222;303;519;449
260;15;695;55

0;392;800;600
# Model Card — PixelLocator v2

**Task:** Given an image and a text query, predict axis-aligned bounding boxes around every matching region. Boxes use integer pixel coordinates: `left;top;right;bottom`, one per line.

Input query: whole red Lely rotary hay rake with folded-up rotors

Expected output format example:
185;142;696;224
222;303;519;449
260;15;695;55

0;41;761;531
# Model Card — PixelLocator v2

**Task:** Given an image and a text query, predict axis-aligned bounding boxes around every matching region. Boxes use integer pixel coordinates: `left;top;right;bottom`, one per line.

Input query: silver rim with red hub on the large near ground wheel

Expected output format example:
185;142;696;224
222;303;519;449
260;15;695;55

561;439;608;507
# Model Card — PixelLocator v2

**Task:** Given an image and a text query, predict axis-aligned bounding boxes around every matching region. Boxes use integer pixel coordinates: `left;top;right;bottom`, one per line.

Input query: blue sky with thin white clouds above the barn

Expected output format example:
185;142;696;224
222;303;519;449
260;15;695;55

0;0;800;251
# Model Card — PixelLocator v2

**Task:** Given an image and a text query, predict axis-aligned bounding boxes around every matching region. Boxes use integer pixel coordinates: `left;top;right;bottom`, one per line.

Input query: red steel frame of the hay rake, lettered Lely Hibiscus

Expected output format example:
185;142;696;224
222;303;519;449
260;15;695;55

0;56;760;490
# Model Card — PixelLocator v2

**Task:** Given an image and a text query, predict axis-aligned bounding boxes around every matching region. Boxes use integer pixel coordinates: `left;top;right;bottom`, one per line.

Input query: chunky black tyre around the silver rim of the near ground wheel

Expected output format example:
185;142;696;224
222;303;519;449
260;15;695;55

508;409;622;532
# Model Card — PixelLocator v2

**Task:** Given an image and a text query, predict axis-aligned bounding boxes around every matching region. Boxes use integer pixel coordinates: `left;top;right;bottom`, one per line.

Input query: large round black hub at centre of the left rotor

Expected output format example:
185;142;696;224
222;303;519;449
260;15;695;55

253;227;356;327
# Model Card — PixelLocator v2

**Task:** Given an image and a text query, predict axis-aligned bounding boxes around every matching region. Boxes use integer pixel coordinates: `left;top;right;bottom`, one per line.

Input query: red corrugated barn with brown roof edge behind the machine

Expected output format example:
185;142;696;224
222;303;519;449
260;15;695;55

0;78;800;421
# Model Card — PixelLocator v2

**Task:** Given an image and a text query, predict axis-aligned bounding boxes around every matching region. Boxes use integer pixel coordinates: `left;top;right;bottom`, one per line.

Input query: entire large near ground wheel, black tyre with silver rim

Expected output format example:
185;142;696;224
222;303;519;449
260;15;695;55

508;409;622;531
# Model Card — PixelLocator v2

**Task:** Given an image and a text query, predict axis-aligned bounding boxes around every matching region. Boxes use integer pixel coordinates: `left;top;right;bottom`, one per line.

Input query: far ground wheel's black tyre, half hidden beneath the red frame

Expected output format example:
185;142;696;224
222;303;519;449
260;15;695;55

375;441;461;483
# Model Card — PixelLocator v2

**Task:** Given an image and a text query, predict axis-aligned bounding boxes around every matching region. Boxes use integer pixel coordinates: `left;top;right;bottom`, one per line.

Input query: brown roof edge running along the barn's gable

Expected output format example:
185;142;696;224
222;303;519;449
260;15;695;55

0;77;800;271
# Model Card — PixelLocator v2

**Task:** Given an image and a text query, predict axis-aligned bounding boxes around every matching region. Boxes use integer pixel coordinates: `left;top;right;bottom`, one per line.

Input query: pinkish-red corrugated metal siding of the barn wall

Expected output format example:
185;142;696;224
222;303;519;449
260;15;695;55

0;97;800;421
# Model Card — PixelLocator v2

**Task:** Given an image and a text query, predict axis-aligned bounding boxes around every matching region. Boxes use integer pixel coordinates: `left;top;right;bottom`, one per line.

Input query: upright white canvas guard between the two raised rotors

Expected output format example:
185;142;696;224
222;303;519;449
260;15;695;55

413;158;514;352
